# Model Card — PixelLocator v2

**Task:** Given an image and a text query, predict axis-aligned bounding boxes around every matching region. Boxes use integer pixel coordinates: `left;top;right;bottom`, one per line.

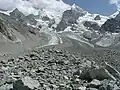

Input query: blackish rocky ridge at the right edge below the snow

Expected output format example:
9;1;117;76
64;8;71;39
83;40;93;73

100;18;120;33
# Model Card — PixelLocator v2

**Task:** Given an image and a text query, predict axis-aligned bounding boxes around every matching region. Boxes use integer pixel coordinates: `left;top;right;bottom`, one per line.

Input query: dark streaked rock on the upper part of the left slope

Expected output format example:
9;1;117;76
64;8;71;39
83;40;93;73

0;9;38;41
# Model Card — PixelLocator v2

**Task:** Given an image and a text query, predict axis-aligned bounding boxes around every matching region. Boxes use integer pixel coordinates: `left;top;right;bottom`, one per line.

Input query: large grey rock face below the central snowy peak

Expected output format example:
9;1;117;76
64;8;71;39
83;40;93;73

56;7;86;31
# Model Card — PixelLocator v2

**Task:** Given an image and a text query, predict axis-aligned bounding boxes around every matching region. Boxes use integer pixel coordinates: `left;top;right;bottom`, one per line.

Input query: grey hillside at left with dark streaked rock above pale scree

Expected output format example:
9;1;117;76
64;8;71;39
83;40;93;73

0;13;50;58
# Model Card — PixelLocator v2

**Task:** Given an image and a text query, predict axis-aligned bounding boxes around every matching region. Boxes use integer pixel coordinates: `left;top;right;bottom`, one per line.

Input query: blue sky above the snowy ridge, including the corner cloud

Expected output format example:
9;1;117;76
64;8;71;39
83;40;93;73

64;0;117;15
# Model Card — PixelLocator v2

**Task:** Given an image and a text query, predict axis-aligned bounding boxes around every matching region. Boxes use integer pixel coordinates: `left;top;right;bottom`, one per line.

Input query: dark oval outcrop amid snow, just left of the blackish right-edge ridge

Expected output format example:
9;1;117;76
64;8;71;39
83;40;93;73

83;21;100;30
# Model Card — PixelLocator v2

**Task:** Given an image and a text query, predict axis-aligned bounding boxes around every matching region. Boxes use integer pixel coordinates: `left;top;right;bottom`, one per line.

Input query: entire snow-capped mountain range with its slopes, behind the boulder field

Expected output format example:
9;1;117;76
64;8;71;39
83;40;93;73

0;0;120;58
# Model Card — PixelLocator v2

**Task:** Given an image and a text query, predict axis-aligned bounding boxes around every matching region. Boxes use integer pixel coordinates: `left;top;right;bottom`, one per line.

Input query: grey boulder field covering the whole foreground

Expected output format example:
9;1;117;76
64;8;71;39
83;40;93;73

0;46;120;90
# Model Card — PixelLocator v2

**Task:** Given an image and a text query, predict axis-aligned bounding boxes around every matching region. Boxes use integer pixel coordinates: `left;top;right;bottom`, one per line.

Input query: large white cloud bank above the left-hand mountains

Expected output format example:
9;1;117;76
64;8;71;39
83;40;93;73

0;0;68;14
